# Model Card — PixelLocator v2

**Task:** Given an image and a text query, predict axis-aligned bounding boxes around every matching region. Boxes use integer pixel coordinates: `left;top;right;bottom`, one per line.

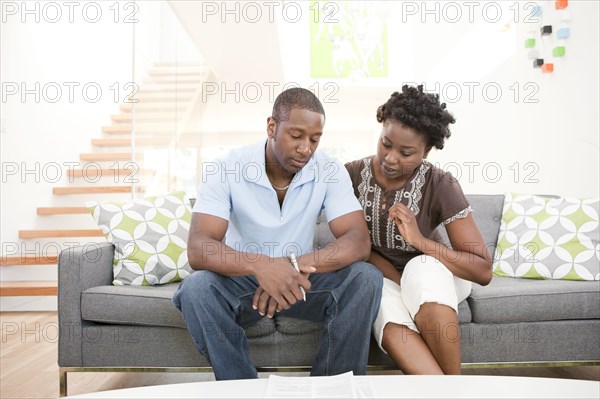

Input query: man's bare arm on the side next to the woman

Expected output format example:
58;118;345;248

298;210;371;273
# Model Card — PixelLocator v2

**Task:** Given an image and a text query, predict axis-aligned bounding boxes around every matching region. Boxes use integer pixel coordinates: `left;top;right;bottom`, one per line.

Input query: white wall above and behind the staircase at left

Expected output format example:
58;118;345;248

0;1;199;247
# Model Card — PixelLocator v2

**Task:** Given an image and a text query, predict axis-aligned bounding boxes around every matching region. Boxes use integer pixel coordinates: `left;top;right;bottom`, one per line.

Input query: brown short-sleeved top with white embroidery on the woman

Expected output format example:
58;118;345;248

346;156;472;271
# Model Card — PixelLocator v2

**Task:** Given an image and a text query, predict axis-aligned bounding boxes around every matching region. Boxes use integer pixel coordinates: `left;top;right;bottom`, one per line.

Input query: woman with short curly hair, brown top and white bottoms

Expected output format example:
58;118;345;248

346;86;492;374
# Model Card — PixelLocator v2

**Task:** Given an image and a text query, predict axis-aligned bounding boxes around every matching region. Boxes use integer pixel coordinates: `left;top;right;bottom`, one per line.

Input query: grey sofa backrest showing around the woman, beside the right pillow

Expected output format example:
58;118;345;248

314;194;504;256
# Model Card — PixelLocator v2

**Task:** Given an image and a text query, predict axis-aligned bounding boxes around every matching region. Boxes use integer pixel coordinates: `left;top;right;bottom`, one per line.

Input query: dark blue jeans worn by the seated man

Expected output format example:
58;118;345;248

173;262;383;380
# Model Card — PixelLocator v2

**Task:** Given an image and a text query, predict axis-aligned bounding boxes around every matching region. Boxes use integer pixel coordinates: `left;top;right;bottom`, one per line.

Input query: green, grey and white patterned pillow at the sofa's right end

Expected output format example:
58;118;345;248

492;193;600;280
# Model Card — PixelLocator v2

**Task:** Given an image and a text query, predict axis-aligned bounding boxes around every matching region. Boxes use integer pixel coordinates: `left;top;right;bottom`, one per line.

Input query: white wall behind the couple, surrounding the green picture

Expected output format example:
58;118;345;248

188;1;600;196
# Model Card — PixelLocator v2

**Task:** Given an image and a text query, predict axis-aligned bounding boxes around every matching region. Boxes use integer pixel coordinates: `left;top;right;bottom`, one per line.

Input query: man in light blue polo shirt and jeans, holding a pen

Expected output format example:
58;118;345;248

173;88;382;380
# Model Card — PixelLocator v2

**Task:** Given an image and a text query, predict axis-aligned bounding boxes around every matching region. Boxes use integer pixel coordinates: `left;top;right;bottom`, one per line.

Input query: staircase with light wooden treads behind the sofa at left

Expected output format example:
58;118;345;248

0;64;206;297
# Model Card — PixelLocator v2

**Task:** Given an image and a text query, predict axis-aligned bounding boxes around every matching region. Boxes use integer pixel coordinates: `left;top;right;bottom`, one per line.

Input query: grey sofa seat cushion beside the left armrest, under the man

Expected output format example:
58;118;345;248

81;283;275;338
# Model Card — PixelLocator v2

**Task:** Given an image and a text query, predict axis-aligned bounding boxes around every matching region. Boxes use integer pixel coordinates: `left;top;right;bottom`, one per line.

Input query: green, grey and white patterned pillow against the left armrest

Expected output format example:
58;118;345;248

86;191;192;285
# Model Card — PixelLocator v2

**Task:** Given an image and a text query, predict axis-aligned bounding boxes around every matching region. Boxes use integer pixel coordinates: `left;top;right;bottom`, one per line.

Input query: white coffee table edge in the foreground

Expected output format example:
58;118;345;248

69;375;600;399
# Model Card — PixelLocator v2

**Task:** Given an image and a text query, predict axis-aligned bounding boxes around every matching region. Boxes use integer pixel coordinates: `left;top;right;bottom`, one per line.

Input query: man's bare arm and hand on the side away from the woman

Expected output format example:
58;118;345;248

188;213;315;309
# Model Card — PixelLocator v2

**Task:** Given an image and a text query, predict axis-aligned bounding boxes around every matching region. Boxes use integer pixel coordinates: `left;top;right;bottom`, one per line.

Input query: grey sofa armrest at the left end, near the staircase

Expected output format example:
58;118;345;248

58;242;115;367
